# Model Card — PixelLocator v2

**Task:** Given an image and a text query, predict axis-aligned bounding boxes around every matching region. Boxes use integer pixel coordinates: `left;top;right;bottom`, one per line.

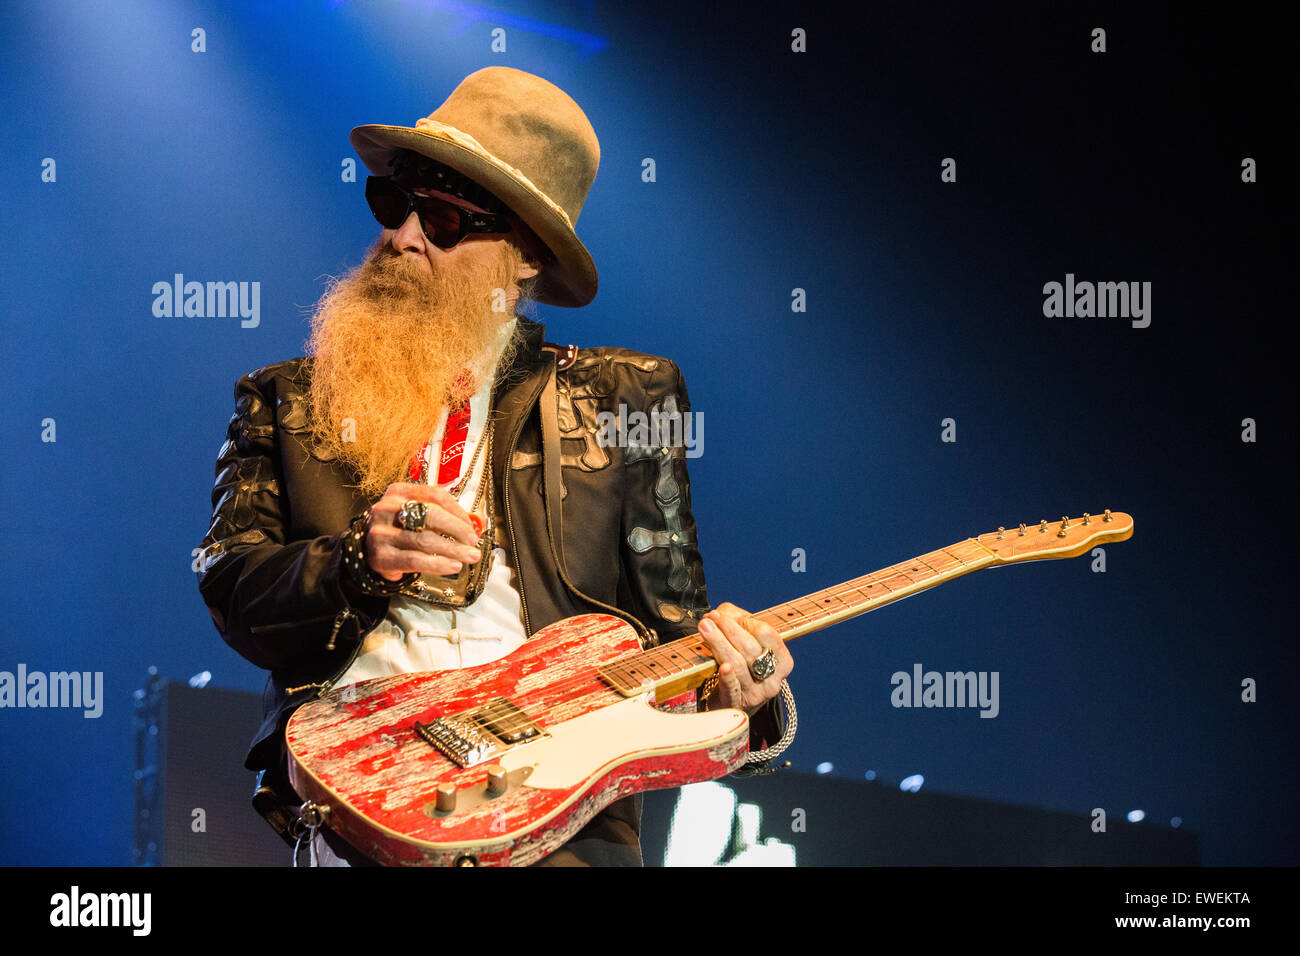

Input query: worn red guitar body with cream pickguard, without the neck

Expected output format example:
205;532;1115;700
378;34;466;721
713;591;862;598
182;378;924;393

286;614;749;866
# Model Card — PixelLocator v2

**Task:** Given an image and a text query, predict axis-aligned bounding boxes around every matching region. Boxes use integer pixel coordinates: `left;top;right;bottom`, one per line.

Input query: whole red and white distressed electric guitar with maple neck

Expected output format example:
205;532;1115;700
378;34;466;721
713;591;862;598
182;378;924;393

286;511;1134;866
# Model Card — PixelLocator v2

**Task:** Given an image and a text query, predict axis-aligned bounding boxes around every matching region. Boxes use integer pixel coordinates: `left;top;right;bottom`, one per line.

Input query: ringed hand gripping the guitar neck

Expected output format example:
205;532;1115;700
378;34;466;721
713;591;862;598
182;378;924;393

699;604;794;717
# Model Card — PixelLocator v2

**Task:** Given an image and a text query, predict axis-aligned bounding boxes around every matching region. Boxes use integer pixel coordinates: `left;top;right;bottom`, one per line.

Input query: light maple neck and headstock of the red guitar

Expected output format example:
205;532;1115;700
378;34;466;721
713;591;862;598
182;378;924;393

599;511;1134;701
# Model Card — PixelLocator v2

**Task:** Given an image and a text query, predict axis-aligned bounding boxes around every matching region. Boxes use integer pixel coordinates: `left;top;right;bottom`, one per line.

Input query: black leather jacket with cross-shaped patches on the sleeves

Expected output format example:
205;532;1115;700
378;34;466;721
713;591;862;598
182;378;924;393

198;316;776;868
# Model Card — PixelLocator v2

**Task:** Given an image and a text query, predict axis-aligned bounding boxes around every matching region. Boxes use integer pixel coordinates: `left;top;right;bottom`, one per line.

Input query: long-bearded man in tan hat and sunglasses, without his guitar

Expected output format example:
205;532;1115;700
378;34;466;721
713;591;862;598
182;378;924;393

199;66;793;865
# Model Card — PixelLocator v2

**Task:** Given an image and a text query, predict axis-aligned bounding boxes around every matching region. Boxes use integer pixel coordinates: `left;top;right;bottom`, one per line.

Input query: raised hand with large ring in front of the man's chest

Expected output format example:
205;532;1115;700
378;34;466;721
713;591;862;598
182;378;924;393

364;481;480;581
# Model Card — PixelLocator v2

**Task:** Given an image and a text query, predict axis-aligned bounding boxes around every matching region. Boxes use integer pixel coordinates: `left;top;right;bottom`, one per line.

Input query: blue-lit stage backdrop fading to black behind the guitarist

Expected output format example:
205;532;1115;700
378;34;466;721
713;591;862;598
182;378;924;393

0;0;1300;865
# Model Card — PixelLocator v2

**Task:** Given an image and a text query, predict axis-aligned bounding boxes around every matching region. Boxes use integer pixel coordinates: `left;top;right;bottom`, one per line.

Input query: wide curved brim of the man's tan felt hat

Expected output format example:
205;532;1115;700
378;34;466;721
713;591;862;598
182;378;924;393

351;125;597;308
